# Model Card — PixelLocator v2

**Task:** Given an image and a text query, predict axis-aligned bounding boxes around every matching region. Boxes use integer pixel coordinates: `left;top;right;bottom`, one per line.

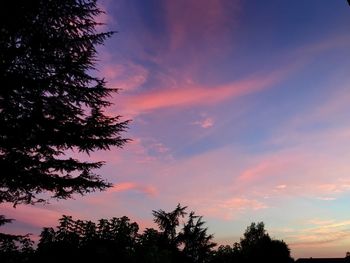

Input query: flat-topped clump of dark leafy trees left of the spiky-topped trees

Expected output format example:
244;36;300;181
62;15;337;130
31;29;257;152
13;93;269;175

36;215;139;262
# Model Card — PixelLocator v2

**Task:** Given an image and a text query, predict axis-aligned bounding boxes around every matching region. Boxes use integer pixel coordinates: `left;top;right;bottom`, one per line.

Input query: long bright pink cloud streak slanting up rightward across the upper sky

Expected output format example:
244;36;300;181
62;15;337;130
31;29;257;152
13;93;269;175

114;33;349;119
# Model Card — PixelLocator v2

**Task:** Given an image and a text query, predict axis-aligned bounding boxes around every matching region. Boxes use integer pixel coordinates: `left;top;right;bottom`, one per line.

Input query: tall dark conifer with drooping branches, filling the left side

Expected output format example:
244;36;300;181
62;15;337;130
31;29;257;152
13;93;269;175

0;0;128;205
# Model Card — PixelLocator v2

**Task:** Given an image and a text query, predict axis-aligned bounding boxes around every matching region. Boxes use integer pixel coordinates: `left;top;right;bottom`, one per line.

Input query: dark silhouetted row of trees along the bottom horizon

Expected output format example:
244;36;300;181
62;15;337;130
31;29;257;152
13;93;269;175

0;204;294;263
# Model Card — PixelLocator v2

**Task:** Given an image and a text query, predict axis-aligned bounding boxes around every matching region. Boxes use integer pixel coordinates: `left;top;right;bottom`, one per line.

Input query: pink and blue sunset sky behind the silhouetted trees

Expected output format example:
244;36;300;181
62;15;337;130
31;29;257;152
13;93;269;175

1;0;350;258
